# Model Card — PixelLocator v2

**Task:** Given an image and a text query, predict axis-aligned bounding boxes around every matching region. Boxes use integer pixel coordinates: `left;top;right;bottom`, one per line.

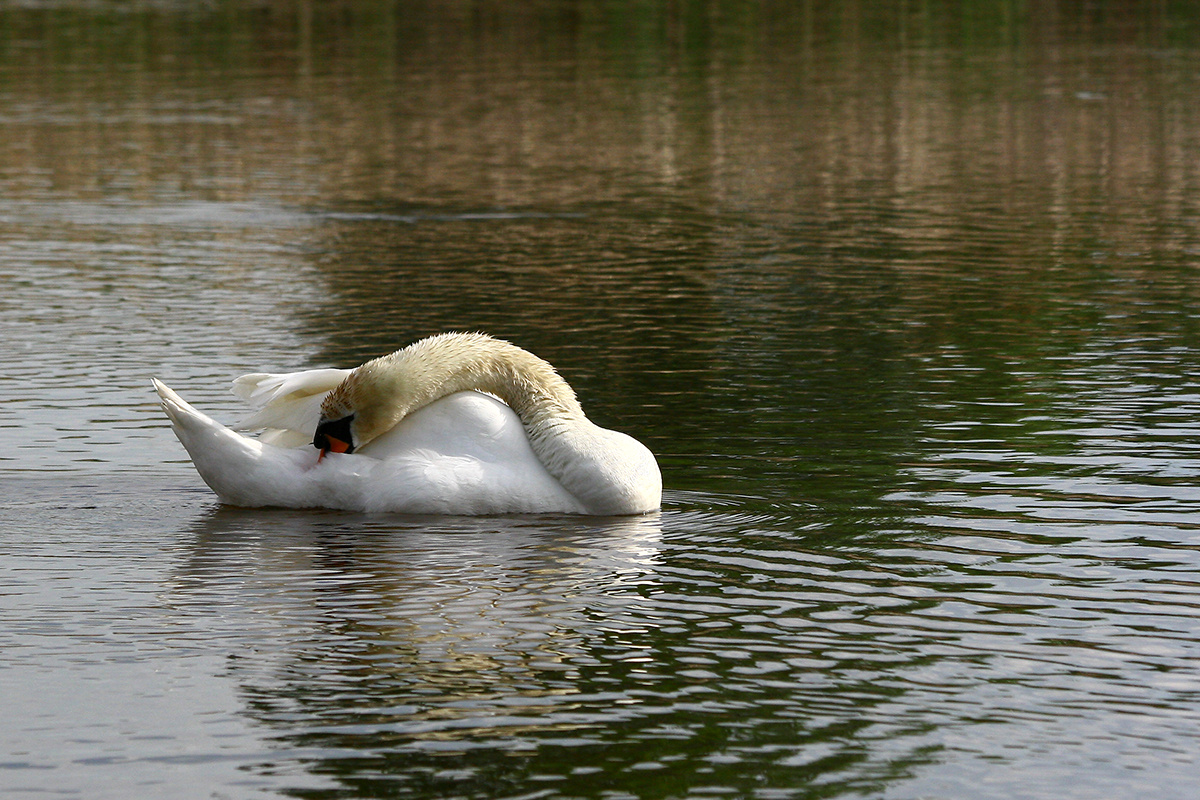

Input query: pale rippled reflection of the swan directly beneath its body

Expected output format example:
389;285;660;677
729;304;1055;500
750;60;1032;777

170;509;662;756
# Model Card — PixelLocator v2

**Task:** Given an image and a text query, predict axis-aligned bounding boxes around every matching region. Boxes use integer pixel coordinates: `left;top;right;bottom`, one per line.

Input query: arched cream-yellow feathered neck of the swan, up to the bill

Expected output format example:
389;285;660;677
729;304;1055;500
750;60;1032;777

322;333;586;450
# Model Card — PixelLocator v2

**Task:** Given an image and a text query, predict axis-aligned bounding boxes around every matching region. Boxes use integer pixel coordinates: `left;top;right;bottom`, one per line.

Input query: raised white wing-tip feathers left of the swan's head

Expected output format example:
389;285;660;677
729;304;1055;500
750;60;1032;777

233;369;350;447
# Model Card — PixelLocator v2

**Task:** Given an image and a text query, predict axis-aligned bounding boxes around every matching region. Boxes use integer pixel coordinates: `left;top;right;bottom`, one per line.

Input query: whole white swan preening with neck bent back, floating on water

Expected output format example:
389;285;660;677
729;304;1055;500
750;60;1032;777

152;333;662;516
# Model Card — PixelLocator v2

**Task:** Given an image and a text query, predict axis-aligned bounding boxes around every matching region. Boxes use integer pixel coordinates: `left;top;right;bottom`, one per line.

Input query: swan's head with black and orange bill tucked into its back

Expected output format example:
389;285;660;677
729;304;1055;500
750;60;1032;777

312;359;404;457
